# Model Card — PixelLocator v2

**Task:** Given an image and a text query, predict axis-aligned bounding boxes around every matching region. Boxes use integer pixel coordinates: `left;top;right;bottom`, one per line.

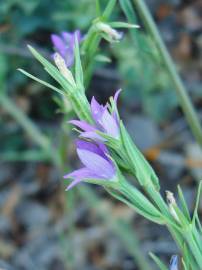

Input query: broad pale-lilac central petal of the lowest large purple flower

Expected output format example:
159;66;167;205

77;149;115;179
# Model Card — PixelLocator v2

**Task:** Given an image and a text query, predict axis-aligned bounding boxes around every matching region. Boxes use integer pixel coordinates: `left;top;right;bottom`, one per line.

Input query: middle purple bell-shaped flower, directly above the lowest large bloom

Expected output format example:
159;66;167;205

70;90;121;141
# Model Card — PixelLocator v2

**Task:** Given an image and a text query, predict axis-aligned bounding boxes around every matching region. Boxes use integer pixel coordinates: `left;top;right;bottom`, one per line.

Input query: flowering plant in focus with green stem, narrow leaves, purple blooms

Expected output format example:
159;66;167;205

18;1;202;270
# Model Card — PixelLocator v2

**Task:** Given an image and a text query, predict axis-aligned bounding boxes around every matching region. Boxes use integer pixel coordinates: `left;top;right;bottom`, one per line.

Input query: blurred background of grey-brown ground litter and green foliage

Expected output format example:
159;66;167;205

0;0;202;270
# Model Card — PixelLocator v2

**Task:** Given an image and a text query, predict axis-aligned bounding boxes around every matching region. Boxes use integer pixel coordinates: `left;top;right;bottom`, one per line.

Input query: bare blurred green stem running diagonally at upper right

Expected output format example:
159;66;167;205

133;0;202;146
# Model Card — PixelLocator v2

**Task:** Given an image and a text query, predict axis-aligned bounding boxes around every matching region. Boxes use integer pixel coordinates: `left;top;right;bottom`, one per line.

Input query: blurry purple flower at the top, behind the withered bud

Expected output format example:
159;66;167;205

51;30;82;67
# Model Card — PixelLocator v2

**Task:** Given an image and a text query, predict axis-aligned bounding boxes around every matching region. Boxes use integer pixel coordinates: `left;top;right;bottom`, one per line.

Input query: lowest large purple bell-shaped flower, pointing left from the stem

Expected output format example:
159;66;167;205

64;140;116;190
